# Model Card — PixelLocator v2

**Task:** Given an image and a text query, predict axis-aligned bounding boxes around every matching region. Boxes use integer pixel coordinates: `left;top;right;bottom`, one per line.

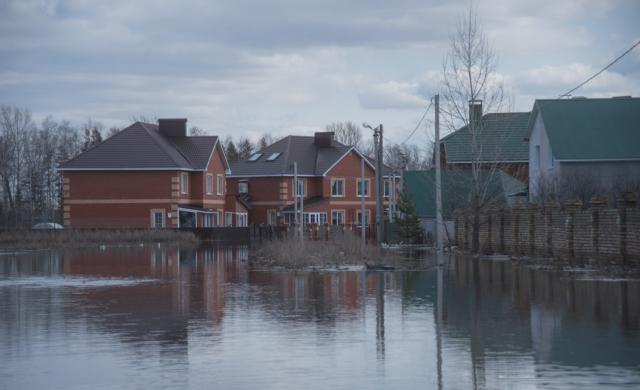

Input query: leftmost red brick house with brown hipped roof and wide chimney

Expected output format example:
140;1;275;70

60;119;248;228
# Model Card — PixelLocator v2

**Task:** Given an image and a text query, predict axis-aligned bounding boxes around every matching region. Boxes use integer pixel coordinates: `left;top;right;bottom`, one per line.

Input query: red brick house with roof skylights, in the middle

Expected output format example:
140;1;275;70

227;132;392;225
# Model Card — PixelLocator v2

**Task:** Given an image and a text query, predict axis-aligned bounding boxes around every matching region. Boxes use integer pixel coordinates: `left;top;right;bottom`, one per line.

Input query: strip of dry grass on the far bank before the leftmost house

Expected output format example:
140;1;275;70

0;229;198;249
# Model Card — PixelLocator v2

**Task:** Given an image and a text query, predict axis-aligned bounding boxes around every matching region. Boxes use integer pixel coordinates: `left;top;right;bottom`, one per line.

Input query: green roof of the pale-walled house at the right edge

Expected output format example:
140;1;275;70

529;97;640;160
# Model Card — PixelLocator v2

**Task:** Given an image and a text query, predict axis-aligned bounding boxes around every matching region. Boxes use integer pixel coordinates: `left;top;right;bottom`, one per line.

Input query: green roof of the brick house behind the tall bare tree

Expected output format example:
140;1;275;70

442;112;530;163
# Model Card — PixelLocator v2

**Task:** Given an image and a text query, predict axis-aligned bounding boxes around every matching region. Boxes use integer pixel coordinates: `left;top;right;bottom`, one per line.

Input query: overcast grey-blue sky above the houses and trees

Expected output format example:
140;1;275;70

0;0;640;142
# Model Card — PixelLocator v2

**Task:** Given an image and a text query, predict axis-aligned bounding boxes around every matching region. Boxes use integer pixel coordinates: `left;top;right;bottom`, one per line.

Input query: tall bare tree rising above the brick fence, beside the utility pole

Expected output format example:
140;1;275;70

442;7;506;252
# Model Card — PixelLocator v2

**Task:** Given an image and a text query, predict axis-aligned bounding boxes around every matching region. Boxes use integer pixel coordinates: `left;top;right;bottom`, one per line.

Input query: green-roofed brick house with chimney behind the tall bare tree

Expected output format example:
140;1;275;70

440;102;530;181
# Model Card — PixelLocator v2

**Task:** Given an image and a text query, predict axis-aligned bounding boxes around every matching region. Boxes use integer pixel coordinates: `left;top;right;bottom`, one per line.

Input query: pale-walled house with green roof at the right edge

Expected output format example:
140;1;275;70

528;96;640;201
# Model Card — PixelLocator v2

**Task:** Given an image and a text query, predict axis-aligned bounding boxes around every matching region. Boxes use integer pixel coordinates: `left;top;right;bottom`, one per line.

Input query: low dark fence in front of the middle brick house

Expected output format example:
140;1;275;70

250;224;376;241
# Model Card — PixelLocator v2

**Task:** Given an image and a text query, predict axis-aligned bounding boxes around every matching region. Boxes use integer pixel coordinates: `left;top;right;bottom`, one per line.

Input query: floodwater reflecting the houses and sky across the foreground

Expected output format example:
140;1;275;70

0;246;640;390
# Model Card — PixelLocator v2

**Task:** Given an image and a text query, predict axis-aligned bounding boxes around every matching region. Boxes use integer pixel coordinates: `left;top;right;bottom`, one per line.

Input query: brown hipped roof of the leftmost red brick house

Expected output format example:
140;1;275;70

60;122;218;170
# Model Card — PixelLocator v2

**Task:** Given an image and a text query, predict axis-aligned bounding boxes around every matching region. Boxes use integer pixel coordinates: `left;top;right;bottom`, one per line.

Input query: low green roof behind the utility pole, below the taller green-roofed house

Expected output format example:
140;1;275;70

403;169;526;218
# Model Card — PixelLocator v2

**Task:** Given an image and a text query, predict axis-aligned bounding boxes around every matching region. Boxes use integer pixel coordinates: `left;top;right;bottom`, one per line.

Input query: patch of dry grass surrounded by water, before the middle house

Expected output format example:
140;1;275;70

250;233;402;269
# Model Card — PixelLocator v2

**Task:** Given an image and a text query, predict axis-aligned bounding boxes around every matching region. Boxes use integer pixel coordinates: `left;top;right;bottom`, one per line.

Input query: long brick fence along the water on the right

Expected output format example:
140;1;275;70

454;193;640;263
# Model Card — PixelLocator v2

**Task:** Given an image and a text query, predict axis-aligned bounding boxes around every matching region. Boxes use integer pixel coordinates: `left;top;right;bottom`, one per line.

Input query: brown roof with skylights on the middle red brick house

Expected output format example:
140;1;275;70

231;135;376;176
